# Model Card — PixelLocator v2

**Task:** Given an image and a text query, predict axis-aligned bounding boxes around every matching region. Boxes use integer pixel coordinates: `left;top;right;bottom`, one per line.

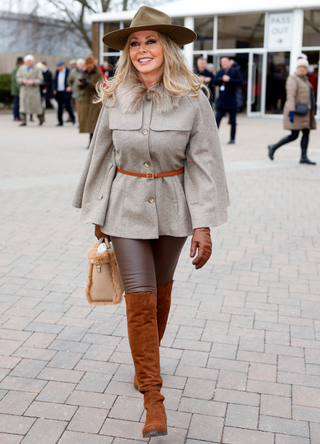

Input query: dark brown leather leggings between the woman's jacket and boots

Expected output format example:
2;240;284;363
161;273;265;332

111;236;187;294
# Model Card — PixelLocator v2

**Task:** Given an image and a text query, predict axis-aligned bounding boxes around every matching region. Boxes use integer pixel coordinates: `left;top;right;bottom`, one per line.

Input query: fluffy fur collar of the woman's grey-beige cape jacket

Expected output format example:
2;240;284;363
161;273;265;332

116;71;181;113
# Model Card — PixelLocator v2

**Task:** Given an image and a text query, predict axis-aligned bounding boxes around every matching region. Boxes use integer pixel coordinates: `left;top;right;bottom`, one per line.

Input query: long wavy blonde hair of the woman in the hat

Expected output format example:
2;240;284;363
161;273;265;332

94;32;210;108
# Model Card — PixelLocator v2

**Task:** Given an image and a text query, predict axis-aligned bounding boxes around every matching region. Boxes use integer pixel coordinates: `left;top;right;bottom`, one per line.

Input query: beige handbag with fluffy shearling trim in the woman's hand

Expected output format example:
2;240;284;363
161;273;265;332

85;237;124;305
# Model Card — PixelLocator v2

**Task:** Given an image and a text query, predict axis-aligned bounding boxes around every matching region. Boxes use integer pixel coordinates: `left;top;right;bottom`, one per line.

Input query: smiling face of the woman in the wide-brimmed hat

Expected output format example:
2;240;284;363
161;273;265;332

129;31;164;83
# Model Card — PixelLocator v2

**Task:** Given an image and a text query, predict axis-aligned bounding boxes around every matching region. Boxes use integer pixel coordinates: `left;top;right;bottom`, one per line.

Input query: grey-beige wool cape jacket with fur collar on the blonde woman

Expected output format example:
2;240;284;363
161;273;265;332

73;75;229;239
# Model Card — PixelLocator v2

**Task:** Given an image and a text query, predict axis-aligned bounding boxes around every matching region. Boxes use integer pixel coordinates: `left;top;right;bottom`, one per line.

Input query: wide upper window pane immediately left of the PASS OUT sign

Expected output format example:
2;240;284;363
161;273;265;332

218;14;264;49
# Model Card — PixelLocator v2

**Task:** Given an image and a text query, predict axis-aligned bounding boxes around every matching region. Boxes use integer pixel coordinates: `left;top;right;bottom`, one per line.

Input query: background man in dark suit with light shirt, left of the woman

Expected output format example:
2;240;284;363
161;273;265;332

53;60;76;126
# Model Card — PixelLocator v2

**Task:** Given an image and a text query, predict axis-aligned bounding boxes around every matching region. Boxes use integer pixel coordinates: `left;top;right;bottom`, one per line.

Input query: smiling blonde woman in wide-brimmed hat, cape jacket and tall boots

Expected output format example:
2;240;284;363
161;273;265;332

73;7;229;437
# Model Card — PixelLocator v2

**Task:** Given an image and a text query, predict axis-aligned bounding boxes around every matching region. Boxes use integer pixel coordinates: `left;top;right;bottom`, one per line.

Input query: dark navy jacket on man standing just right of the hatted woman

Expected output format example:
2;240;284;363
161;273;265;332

213;68;243;110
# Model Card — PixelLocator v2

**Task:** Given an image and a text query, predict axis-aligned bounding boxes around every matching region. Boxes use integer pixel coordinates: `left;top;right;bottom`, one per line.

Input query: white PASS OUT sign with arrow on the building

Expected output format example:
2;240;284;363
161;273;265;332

268;12;293;49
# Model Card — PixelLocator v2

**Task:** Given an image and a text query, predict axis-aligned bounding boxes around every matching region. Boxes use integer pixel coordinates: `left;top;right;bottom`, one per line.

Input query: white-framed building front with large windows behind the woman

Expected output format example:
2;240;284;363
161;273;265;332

92;0;320;117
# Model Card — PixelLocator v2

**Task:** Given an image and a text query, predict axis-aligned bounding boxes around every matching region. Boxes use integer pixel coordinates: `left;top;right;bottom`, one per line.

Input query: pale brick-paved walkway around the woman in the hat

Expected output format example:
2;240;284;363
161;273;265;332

0;110;320;444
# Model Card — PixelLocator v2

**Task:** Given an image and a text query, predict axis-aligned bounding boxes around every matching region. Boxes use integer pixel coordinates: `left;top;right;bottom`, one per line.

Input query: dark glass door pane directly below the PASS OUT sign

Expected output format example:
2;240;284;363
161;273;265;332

266;52;290;114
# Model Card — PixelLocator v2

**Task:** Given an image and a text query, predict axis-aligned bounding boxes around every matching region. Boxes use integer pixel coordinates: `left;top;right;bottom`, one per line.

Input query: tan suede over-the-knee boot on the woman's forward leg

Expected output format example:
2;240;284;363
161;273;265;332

125;292;167;438
